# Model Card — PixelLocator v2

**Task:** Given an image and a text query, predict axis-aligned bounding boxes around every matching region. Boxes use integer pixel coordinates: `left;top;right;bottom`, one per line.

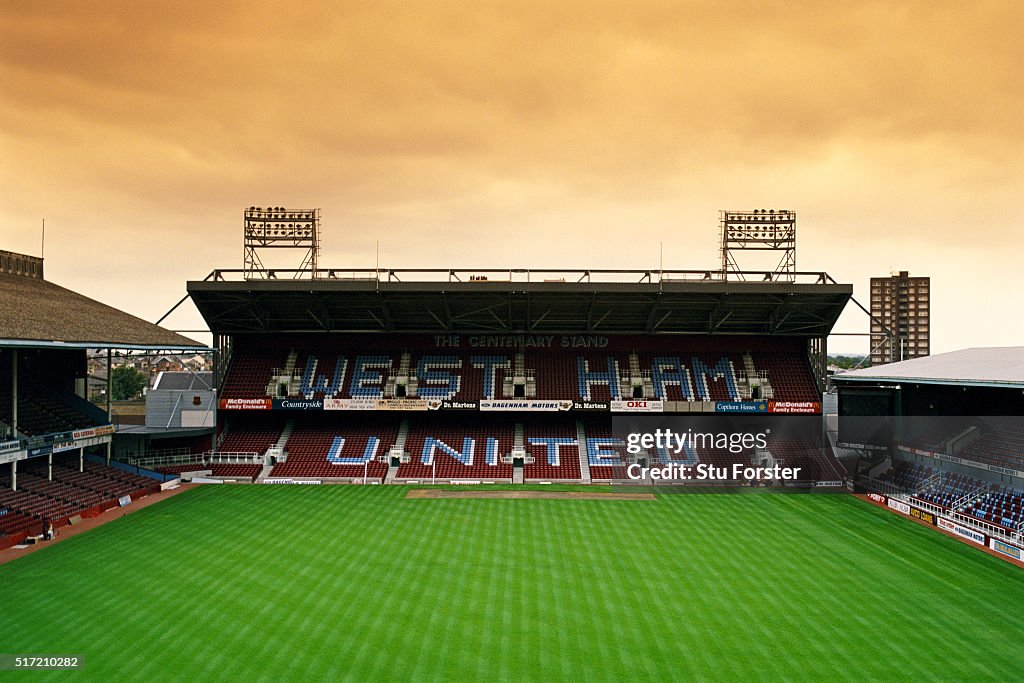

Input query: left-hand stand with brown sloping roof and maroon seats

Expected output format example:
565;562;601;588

0;251;206;546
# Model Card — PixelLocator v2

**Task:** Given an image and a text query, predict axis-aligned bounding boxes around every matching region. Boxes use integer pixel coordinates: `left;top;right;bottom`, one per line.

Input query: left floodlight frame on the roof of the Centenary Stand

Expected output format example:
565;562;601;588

243;207;321;280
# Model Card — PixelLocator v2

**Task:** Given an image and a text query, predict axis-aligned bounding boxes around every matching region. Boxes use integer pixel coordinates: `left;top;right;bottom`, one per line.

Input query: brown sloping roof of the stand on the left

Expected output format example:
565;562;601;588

0;272;207;350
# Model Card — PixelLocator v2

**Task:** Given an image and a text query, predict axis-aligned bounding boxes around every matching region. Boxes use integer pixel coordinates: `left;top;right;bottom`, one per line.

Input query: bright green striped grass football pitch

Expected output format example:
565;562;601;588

0;485;1024;681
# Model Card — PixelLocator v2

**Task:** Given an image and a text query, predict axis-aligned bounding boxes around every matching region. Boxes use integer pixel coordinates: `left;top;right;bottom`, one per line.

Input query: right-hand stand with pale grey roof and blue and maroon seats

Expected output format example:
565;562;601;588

834;347;1024;543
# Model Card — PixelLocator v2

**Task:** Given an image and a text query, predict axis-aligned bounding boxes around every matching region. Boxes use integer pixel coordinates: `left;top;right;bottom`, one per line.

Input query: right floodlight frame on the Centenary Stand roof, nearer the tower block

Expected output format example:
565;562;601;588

718;209;797;283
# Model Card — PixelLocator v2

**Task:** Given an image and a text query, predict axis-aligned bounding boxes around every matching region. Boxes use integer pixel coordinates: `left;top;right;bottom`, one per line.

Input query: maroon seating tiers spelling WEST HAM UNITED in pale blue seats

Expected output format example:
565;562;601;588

218;334;842;481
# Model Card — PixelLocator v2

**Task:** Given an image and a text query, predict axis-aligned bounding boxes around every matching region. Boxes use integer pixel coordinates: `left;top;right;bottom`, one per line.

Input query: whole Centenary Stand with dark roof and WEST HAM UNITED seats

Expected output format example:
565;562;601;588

197;271;851;491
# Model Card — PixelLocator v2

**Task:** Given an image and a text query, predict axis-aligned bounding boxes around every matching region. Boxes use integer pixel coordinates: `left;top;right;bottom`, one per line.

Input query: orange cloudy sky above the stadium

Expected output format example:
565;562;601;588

0;0;1024;351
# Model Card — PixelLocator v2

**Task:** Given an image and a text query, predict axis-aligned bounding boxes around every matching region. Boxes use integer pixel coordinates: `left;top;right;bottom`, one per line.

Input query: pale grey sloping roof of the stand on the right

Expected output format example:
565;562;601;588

833;346;1024;388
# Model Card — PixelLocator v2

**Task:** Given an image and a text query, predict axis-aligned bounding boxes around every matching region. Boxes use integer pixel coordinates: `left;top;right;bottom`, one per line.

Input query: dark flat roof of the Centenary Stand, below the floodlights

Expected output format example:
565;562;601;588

187;270;853;337
